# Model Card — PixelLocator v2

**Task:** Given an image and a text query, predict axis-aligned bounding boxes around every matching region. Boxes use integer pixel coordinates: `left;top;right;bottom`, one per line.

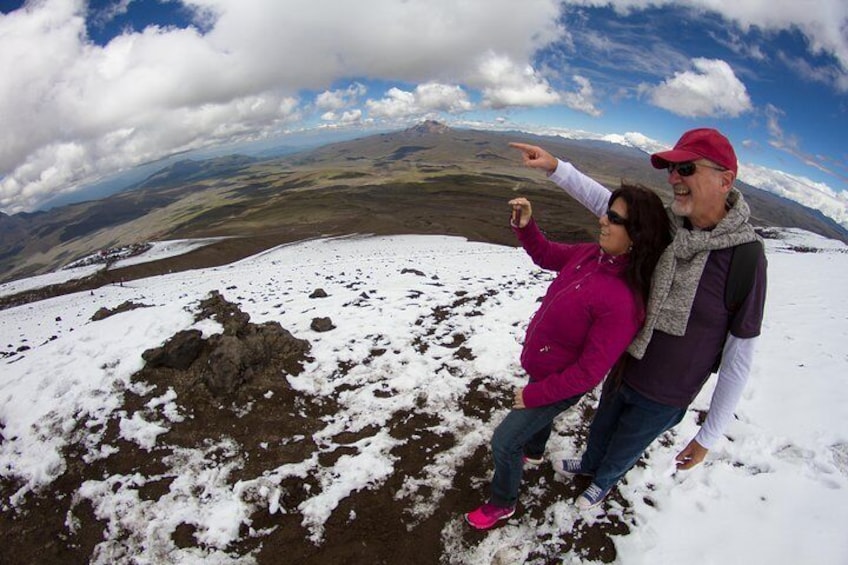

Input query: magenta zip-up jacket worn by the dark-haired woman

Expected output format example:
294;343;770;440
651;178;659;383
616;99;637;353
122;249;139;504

513;219;645;408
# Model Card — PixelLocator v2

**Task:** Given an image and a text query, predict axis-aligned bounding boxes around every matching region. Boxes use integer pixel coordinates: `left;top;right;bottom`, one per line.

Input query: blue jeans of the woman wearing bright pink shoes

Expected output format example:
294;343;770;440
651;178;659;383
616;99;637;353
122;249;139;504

489;394;583;507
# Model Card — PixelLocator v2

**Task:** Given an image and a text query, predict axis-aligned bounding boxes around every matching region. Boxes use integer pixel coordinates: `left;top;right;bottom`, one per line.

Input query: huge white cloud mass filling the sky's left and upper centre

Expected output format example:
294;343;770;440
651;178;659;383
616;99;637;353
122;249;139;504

0;0;560;213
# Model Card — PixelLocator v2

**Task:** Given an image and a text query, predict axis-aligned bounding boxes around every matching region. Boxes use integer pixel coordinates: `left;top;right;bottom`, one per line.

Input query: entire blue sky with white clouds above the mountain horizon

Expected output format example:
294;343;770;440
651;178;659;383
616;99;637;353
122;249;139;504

0;0;848;225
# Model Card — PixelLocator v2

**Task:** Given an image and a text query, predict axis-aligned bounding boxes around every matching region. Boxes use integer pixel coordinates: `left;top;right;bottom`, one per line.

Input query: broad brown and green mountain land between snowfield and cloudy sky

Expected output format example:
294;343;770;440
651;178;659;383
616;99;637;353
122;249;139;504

0;121;848;280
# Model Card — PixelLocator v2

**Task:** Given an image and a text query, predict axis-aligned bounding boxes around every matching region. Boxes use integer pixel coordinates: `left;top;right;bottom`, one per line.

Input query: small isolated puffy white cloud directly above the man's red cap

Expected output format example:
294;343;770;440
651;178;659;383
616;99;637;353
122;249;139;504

641;58;752;117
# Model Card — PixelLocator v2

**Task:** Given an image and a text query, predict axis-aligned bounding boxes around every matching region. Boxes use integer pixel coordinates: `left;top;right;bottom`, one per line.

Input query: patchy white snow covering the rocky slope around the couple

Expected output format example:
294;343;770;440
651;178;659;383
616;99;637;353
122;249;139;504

0;230;848;565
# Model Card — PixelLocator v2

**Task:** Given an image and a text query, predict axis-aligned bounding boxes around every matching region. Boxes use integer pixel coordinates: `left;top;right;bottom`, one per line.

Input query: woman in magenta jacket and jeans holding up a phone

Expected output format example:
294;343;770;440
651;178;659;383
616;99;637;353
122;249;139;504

465;185;670;530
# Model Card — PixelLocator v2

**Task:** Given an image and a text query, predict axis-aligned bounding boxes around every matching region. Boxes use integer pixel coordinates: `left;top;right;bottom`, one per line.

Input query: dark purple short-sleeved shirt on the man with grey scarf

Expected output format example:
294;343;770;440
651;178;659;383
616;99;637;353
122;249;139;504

624;248;766;408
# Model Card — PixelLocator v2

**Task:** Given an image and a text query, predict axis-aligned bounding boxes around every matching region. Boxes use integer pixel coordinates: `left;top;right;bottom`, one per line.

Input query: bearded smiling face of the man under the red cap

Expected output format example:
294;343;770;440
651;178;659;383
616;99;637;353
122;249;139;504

668;159;733;228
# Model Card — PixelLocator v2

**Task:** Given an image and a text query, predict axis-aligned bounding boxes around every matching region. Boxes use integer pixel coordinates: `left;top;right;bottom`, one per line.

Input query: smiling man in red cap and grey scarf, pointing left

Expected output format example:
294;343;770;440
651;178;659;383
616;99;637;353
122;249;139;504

511;128;766;508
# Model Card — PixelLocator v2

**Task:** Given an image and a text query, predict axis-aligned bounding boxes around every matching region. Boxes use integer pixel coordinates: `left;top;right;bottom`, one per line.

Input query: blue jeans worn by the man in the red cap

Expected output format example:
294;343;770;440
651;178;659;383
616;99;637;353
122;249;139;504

580;384;686;489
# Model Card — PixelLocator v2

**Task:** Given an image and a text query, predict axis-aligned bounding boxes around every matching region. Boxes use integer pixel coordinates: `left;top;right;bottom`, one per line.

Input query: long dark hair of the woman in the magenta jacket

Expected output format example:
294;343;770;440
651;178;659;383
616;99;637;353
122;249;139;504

609;183;671;308
